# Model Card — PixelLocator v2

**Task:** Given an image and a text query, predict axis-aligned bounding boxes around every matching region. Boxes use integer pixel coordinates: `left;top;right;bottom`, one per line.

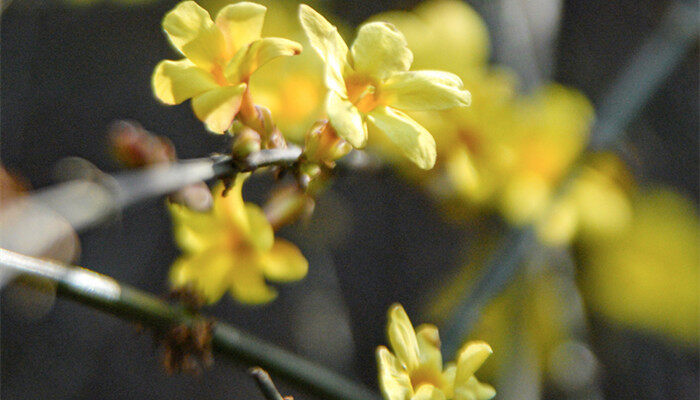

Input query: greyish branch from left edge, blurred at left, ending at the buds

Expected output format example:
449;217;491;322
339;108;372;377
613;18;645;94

0;147;301;254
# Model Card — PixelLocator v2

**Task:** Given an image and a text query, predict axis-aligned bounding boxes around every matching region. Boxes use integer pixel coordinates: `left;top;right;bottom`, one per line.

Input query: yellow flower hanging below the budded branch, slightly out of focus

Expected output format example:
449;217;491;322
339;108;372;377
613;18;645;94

170;174;308;304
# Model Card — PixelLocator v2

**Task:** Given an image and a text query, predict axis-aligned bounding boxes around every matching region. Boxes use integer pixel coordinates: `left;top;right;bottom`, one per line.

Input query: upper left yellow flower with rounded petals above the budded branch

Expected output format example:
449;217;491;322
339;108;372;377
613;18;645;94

152;1;301;133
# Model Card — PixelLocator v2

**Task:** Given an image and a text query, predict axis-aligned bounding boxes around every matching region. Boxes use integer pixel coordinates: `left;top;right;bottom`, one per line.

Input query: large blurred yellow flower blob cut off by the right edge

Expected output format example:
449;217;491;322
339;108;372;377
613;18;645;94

581;188;700;346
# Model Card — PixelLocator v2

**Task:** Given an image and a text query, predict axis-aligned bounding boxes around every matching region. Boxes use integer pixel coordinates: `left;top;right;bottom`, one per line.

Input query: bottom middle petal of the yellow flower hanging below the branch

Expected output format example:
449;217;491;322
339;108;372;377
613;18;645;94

228;251;277;304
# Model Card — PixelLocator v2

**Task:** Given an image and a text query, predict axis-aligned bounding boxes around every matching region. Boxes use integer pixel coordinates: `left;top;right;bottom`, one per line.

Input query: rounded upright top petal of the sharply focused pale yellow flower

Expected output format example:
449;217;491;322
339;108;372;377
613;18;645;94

350;22;413;81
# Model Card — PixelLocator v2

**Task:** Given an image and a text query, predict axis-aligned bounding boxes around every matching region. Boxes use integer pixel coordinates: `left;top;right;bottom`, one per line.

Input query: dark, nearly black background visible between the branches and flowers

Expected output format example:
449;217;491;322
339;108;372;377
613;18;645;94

0;0;699;399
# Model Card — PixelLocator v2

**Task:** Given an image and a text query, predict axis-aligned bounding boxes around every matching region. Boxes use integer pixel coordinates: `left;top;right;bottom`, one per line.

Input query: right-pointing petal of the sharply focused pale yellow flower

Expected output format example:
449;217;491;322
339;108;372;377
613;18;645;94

382;71;471;111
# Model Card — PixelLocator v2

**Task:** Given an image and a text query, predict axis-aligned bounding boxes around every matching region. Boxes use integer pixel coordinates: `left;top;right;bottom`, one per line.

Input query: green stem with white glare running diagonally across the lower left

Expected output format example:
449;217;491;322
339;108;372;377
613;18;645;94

0;249;379;400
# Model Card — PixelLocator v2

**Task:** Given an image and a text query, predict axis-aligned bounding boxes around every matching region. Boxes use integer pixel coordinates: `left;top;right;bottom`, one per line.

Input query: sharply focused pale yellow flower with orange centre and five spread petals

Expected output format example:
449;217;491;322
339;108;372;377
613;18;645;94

299;5;470;169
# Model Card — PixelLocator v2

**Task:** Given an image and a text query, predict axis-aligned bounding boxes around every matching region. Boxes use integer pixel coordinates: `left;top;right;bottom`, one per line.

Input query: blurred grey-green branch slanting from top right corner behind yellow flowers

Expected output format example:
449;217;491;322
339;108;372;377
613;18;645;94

441;2;698;354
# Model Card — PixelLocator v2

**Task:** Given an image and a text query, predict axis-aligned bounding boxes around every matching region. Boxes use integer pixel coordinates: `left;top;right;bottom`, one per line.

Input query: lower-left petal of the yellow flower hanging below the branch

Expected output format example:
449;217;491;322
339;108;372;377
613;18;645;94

170;249;233;303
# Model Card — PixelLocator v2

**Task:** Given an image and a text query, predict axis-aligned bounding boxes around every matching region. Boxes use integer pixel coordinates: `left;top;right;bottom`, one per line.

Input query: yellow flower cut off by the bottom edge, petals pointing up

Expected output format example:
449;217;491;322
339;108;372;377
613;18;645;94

377;304;496;400
